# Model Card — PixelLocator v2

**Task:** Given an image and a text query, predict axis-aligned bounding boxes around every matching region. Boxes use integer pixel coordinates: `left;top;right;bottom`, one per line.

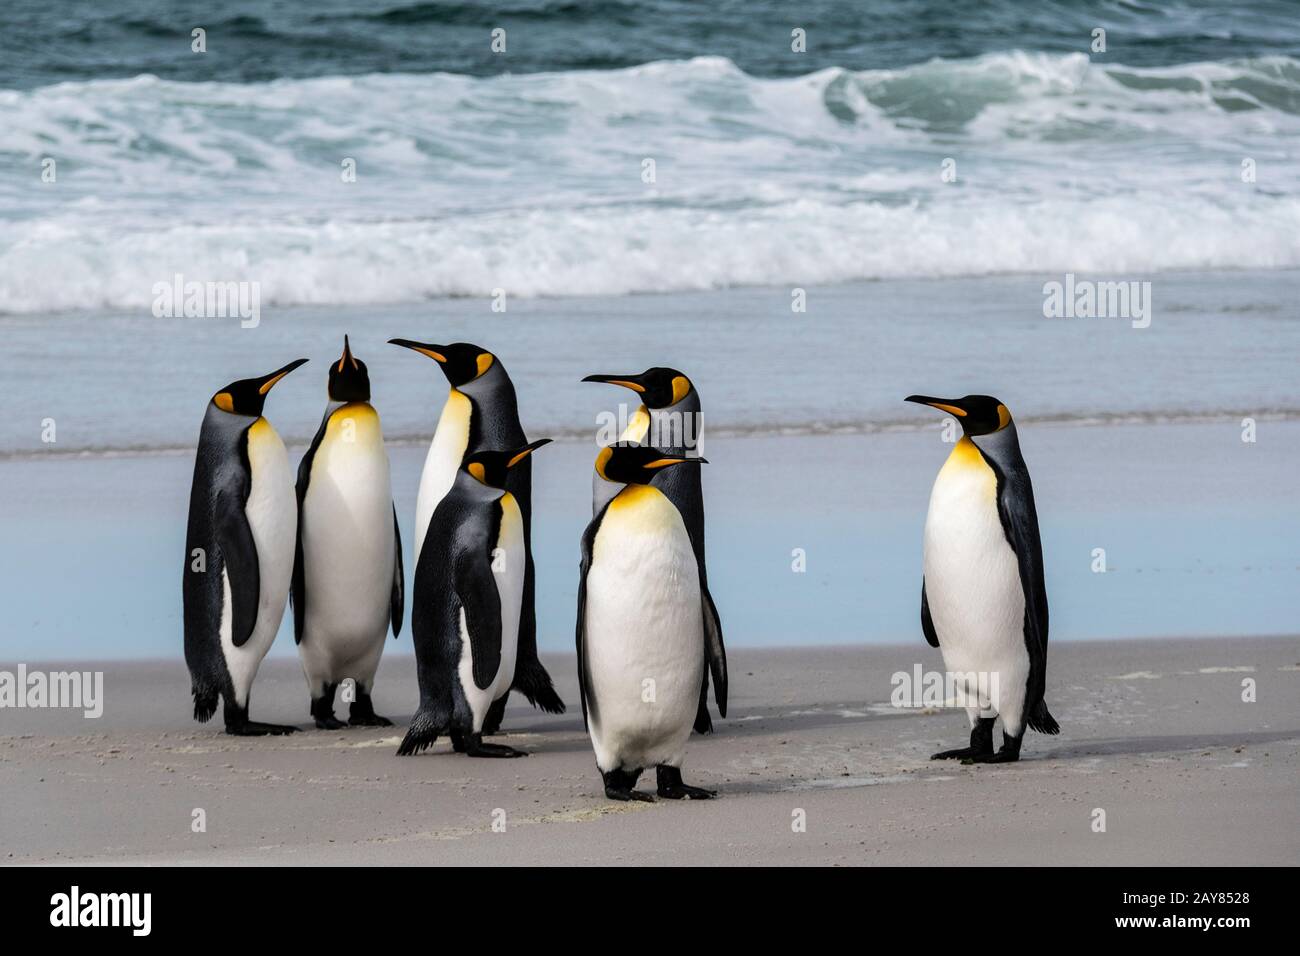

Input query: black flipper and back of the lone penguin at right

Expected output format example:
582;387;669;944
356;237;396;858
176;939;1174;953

991;462;1061;734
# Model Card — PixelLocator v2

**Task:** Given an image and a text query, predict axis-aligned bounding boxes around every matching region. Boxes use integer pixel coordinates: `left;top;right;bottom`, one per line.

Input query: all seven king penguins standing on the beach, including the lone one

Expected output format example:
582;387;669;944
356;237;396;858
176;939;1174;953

182;337;1058;800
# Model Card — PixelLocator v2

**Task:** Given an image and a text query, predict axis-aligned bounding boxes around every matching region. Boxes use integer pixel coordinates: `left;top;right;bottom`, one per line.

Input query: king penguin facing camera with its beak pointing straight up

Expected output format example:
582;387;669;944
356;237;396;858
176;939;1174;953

291;336;404;730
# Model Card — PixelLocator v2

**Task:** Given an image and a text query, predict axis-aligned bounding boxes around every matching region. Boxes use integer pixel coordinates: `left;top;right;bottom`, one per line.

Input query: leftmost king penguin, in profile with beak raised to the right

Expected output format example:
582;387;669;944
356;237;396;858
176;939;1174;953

181;359;307;736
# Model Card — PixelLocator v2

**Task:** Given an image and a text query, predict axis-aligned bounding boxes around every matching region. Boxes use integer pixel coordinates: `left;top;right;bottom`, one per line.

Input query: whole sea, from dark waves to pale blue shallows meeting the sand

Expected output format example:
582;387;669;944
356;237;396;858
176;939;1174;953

0;0;1300;661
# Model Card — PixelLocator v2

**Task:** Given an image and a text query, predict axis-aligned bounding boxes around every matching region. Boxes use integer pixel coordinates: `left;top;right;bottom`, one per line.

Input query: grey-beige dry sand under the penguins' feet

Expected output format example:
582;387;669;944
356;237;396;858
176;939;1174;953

0;637;1300;865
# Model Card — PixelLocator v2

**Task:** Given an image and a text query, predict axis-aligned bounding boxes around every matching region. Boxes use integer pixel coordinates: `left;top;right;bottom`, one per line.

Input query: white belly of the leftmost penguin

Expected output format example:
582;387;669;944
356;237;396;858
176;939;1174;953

221;419;298;706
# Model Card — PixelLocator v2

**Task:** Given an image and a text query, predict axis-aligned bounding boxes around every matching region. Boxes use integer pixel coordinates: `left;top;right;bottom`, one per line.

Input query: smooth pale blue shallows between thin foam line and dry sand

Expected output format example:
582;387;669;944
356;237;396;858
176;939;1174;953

0;421;1300;661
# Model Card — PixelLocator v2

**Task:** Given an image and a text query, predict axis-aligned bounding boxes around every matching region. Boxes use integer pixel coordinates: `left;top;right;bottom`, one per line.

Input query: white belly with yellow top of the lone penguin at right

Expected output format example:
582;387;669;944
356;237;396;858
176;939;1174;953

924;438;1030;728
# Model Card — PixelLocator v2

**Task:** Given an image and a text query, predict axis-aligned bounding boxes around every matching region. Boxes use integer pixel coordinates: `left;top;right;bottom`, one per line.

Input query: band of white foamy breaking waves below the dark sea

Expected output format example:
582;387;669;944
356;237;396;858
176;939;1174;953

0;52;1300;313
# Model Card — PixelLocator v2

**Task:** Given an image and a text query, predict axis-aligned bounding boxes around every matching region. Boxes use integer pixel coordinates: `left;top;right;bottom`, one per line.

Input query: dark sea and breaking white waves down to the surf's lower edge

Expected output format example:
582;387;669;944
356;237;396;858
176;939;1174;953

0;0;1300;315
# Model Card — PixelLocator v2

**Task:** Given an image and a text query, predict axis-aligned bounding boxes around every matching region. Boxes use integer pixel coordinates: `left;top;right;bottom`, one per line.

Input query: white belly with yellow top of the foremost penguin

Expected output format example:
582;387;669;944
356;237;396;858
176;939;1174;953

584;486;705;771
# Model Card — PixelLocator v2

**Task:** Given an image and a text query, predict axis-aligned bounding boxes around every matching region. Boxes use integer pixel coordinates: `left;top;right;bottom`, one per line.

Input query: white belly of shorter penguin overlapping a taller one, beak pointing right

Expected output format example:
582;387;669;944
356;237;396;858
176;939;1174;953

458;492;527;734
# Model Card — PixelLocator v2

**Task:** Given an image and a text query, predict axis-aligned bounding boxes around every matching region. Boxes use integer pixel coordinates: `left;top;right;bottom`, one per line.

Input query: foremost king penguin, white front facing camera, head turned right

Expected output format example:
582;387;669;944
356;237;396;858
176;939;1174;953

576;445;727;800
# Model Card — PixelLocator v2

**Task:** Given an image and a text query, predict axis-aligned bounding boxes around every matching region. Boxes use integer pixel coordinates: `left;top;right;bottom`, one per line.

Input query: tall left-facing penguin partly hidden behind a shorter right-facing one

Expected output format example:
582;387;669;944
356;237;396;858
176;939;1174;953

389;338;564;736
